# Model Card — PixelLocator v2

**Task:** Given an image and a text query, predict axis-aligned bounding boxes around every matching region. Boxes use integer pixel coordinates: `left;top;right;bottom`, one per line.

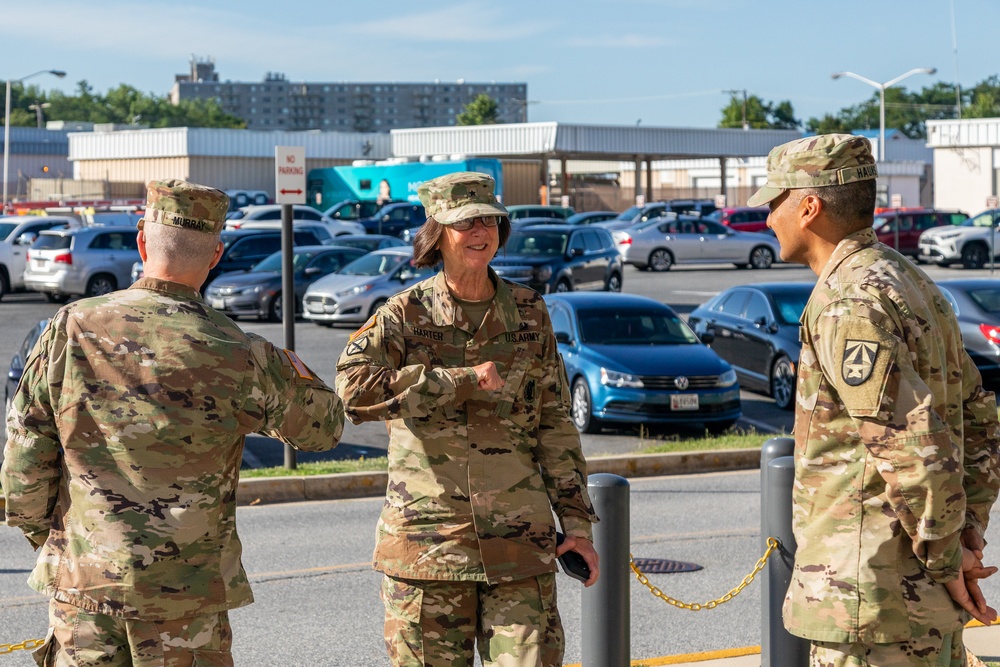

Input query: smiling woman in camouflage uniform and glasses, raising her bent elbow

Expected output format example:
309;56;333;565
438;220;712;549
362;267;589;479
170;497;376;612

337;172;598;667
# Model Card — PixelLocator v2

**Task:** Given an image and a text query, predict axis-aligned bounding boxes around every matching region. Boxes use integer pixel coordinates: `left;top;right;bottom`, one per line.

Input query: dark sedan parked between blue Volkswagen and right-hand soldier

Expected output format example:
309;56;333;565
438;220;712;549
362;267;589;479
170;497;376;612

688;282;814;410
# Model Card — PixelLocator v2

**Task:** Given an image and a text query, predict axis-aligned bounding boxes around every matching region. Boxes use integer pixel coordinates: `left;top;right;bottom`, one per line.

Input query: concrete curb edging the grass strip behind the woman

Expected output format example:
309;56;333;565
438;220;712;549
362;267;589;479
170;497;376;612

236;448;760;505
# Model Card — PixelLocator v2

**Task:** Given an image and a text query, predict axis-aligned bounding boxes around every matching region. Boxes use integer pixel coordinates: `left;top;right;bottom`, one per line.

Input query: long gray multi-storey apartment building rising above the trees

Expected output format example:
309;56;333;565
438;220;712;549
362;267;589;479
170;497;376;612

170;57;528;132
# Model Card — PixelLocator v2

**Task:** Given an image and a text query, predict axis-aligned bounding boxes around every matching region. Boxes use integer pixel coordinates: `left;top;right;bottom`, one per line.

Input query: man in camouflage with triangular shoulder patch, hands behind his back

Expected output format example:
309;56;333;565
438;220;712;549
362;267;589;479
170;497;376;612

749;134;1000;667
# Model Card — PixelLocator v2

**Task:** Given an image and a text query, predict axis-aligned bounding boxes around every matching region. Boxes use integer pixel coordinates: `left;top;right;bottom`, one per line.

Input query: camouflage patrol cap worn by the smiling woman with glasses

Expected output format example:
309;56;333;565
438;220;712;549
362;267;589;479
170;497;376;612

417;171;507;225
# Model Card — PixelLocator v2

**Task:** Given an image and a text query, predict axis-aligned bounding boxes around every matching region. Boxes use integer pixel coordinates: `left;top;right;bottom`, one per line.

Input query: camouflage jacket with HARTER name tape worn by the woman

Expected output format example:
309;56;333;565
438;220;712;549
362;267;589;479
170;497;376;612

337;271;597;583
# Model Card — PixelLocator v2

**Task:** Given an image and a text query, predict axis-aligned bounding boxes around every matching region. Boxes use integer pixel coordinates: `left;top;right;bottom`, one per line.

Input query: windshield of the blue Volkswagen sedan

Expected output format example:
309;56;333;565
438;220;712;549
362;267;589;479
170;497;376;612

577;308;698;345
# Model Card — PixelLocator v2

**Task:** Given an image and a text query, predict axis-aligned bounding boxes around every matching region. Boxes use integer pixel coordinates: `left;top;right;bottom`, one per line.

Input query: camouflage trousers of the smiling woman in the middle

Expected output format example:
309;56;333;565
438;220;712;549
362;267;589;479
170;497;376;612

381;573;564;667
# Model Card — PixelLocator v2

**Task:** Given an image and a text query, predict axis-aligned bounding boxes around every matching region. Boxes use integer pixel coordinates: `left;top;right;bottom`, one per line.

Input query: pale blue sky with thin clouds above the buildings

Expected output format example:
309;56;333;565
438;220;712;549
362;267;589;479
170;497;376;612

0;0;1000;127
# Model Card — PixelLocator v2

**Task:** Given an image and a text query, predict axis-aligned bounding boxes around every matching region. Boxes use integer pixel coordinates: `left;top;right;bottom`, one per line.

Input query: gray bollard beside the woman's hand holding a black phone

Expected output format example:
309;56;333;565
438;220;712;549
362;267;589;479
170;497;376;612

581;473;632;667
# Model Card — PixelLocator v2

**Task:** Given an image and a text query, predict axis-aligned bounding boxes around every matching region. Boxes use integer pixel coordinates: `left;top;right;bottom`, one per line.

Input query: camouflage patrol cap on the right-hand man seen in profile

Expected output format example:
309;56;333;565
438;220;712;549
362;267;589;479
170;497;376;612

747;134;878;206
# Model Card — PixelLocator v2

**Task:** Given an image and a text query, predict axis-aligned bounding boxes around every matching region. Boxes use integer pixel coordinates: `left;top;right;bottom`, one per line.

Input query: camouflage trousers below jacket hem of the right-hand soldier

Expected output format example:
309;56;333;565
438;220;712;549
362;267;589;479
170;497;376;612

809;629;966;667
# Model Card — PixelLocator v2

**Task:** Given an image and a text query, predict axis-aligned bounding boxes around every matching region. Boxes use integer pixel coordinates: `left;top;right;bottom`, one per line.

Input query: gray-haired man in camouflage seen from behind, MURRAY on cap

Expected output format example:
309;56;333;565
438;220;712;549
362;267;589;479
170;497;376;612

2;180;344;667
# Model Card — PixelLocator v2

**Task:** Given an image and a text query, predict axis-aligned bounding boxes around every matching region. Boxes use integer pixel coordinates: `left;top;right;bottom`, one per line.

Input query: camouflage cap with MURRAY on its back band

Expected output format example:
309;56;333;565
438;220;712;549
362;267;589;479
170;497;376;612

137;179;229;234
